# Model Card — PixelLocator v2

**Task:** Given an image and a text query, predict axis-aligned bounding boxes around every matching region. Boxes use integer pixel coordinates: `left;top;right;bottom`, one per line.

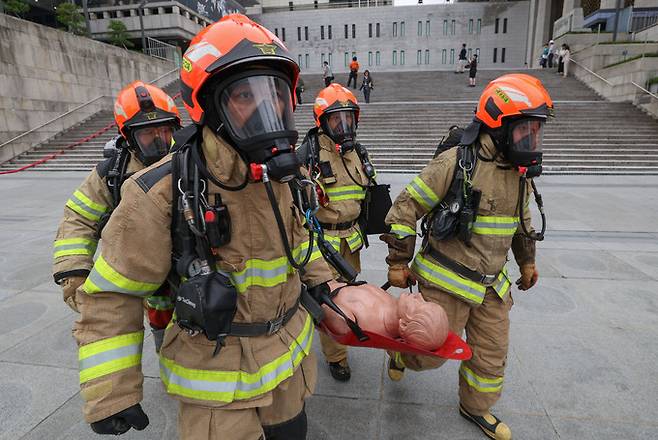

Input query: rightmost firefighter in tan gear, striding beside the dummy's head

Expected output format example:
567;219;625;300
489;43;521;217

381;74;553;440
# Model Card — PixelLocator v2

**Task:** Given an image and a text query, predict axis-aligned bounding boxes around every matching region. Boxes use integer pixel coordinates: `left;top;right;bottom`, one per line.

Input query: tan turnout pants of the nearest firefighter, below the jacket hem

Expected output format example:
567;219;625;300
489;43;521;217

178;353;316;440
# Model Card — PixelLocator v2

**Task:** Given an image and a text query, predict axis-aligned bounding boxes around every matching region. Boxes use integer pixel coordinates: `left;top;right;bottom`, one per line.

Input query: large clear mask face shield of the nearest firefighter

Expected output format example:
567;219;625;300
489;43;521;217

215;74;297;152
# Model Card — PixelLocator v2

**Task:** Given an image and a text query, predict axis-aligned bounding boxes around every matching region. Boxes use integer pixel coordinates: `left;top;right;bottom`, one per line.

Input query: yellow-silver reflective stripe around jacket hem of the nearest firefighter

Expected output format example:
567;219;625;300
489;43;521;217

160;315;313;403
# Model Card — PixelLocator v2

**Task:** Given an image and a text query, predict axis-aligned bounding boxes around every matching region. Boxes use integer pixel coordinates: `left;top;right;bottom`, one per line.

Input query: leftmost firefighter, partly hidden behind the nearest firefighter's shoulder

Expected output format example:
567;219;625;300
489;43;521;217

53;81;181;350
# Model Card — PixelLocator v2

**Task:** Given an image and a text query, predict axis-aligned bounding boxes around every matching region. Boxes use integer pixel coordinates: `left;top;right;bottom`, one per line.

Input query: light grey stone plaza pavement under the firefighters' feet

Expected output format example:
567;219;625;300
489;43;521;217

0;172;658;440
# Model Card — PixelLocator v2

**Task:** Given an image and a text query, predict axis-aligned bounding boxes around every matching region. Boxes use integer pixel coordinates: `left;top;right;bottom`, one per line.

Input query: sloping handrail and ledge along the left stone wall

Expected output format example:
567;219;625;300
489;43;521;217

0;68;178;163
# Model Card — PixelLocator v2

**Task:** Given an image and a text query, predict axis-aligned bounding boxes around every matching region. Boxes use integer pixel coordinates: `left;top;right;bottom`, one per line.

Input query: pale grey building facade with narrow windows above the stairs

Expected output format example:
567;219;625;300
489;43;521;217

255;0;530;74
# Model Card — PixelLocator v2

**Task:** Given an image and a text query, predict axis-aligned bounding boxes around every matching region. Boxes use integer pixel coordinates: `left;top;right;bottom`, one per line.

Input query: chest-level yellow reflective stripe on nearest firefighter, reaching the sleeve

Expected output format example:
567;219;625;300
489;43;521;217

229;241;322;293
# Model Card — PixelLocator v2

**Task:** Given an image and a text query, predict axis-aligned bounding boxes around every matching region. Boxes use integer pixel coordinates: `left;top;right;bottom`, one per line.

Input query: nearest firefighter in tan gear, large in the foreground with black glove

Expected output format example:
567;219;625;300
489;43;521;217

74;14;332;440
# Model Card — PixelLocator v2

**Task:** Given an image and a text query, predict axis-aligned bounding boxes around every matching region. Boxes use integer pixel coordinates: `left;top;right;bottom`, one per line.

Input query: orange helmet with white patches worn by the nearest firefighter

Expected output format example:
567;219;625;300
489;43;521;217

181;14;299;124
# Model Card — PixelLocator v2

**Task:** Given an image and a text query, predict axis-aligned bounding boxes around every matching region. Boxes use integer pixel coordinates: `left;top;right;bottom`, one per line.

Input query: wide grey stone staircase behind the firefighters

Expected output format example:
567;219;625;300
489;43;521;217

0;70;658;174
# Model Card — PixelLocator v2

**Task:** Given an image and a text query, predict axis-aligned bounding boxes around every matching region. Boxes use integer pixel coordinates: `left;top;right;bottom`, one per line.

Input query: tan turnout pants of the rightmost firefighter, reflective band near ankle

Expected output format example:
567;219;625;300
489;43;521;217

392;285;514;415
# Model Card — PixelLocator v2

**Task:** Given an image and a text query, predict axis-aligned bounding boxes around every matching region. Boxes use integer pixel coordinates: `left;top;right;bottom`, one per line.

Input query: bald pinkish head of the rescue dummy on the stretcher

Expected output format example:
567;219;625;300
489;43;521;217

398;293;448;351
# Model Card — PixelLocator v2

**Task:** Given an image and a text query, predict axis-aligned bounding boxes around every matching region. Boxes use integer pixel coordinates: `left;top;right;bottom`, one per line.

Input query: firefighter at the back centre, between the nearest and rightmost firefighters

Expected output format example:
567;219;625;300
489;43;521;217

298;83;370;382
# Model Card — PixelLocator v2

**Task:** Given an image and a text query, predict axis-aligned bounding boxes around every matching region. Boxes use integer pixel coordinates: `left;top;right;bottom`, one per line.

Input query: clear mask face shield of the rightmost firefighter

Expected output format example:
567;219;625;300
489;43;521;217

507;118;546;167
